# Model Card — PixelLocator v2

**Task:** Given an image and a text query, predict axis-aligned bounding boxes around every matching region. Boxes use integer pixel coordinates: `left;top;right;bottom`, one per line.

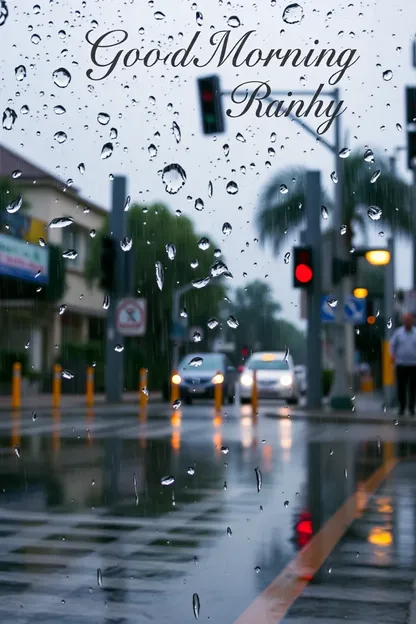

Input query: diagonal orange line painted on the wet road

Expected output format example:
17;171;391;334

235;456;398;624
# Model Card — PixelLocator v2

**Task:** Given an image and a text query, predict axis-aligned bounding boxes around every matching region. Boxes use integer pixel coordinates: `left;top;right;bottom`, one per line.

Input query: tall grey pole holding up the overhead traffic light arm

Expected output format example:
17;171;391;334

331;89;352;410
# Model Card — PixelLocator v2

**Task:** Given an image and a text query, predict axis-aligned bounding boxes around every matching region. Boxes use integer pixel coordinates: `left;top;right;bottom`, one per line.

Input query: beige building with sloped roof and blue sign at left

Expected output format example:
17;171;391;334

0;145;107;382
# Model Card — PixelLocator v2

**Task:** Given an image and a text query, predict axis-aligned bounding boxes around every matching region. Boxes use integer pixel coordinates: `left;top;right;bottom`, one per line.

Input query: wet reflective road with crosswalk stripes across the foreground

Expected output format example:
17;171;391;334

0;405;416;624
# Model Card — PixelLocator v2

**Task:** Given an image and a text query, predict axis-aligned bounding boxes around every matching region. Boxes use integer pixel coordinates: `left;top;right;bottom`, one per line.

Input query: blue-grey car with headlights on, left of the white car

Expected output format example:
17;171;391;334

171;353;238;405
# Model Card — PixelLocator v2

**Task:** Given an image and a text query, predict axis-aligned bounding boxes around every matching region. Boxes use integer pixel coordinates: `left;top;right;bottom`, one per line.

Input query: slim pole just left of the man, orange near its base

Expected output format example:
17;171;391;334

383;237;395;407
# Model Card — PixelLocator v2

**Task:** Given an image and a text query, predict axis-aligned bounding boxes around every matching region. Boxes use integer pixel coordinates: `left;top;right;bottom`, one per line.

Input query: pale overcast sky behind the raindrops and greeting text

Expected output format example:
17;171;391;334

0;0;416;330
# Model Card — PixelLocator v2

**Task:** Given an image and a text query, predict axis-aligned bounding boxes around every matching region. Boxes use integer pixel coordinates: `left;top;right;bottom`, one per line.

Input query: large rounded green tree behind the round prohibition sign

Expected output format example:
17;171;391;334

86;204;225;387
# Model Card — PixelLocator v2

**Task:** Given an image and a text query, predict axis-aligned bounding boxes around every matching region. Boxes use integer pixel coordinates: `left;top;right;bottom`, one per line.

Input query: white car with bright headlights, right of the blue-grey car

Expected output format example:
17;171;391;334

239;352;300;405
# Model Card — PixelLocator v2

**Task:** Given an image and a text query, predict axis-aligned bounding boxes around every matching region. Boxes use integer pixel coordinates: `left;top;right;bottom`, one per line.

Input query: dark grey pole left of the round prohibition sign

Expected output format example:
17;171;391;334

105;176;127;403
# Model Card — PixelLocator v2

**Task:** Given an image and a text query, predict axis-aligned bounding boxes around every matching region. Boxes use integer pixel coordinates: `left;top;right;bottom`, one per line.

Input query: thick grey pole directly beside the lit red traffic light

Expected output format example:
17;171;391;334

304;171;322;409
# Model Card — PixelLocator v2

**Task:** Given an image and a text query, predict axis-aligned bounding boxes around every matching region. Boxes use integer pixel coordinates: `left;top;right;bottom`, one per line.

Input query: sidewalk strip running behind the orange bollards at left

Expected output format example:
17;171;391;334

0;392;162;412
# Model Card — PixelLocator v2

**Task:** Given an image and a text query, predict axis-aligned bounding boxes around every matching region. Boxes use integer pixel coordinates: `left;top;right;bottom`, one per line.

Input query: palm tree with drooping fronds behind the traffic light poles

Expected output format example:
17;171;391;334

257;150;416;253
